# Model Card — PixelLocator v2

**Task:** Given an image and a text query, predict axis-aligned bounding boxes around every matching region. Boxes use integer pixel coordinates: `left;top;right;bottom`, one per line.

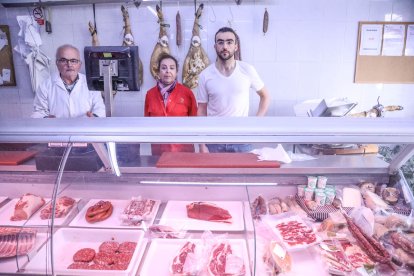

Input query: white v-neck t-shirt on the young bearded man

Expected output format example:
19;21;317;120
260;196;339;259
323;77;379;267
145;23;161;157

198;60;264;117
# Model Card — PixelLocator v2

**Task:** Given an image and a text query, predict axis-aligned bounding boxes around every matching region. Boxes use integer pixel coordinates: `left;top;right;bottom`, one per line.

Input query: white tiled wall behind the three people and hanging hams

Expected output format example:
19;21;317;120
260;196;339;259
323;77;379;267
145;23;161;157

0;0;414;118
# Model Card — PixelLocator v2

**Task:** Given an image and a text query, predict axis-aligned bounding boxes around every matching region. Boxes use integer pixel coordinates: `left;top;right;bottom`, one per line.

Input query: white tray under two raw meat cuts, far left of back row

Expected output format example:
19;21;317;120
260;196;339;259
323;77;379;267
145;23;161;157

0;198;80;226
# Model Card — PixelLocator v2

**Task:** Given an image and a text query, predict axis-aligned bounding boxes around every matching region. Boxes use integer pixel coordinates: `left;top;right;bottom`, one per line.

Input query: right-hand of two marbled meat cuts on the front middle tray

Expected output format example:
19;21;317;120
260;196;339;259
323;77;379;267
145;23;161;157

208;242;246;276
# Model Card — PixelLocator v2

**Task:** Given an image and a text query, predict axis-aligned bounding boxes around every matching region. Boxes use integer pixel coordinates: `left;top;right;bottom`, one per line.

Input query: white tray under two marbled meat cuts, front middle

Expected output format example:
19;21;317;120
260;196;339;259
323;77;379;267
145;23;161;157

139;239;251;276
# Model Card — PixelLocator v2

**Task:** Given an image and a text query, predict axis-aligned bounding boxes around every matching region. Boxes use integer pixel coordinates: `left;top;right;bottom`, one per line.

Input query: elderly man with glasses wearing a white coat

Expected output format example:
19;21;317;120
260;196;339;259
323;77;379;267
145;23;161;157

31;44;105;118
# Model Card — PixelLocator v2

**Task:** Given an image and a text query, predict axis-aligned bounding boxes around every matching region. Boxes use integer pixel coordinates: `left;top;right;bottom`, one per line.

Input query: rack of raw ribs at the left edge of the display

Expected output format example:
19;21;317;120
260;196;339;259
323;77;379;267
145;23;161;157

0;227;36;258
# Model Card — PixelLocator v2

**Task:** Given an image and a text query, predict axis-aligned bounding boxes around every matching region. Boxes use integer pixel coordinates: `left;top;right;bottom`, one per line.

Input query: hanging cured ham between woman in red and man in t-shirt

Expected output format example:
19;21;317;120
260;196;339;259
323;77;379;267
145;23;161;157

183;4;210;89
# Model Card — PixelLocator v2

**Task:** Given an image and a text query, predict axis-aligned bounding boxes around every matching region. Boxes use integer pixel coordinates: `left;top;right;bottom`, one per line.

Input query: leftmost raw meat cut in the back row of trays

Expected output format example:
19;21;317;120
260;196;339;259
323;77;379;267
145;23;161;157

10;193;45;221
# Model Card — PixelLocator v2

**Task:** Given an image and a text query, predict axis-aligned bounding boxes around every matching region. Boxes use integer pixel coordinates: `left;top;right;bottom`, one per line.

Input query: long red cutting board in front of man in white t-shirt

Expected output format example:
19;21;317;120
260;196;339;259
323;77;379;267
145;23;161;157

156;152;280;168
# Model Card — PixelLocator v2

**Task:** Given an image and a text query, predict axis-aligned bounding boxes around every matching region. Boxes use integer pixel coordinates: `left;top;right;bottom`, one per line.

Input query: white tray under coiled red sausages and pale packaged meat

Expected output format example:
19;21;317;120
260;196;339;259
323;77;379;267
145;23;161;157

69;199;161;228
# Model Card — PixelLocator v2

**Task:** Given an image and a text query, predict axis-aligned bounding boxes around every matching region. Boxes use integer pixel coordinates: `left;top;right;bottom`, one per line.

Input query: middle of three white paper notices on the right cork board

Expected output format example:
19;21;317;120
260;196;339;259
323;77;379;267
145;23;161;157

382;24;405;56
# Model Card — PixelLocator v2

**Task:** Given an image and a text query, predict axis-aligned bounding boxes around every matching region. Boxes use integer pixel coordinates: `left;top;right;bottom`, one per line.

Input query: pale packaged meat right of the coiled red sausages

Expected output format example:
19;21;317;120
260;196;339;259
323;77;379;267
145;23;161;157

121;197;155;225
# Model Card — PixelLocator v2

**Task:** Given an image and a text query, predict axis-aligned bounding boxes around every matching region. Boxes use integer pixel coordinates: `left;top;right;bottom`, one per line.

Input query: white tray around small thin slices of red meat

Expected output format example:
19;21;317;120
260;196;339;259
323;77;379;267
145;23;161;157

266;212;321;251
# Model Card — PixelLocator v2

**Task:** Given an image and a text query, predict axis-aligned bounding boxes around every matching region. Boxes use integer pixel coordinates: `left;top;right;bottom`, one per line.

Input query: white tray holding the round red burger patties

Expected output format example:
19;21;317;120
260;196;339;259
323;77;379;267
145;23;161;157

26;228;146;276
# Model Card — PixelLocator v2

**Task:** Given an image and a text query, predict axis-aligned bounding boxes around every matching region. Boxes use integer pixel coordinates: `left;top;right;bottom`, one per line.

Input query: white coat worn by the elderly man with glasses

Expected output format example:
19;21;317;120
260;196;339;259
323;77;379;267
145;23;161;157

31;73;105;118
